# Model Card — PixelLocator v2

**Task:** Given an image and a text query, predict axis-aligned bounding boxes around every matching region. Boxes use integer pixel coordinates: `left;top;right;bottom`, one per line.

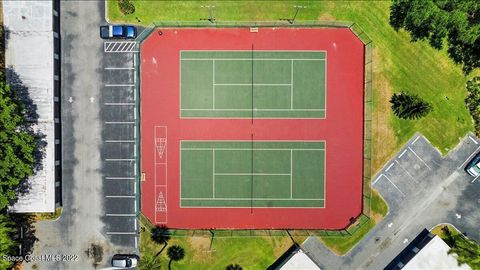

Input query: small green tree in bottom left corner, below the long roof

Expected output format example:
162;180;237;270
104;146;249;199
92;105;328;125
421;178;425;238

0;214;17;269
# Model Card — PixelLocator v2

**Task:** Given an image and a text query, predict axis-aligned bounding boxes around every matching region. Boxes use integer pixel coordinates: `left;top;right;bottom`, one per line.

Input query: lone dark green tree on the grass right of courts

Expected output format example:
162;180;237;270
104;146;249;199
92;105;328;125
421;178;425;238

390;92;432;119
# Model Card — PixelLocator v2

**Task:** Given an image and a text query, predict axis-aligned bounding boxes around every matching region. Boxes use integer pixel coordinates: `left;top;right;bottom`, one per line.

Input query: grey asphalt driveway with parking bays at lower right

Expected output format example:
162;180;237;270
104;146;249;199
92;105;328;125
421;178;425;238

303;134;480;269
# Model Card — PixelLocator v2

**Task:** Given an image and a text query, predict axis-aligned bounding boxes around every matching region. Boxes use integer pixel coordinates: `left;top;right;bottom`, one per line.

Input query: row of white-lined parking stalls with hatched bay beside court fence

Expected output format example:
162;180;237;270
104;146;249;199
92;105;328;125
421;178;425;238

99;41;140;248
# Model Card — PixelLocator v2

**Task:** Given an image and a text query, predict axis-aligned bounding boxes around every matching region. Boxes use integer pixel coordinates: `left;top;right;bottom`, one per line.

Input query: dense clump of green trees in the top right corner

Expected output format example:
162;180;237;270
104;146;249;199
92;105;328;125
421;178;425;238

390;0;480;74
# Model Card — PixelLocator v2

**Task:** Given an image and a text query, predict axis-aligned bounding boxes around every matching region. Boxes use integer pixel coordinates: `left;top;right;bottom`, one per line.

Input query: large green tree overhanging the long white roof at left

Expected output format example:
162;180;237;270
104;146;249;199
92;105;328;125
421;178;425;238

0;80;37;209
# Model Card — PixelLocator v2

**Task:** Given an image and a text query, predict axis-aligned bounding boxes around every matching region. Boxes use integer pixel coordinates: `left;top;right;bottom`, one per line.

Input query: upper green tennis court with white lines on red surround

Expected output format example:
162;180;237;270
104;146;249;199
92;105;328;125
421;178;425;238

180;50;327;118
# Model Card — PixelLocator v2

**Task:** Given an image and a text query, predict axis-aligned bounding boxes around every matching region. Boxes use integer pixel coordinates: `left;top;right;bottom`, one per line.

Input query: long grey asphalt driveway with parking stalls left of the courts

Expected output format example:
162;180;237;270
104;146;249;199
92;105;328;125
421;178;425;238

25;1;139;270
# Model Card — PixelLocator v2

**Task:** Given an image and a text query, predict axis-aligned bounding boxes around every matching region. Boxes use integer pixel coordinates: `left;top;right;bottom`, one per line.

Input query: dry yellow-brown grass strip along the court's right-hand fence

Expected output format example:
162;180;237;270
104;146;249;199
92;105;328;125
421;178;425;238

372;48;397;172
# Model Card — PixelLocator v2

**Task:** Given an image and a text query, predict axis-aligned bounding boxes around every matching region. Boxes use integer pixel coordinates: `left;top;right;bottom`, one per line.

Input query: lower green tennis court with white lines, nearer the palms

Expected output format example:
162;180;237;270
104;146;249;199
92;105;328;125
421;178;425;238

180;141;325;208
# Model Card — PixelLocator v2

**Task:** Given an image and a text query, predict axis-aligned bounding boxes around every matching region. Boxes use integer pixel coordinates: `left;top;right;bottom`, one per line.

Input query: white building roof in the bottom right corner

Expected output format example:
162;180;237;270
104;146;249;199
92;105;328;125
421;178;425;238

402;235;471;270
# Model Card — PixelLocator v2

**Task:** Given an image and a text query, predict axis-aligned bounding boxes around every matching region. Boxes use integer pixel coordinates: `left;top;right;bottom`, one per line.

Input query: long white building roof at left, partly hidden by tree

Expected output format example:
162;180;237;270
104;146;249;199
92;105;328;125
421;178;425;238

3;0;55;212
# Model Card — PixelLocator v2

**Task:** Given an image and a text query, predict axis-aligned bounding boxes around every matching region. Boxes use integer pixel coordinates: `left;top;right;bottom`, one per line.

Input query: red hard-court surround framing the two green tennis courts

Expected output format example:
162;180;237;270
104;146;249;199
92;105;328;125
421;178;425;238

140;28;364;229
